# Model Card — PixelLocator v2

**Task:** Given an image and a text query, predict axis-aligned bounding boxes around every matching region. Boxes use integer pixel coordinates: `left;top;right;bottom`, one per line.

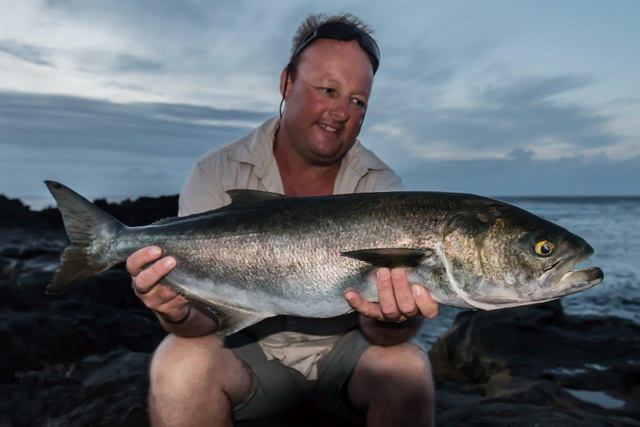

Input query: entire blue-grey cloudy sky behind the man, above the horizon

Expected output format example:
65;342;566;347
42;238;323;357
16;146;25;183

0;0;640;204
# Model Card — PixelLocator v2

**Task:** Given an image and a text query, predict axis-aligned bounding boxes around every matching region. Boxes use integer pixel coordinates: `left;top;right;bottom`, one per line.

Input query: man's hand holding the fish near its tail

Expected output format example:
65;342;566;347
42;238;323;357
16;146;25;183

127;246;191;323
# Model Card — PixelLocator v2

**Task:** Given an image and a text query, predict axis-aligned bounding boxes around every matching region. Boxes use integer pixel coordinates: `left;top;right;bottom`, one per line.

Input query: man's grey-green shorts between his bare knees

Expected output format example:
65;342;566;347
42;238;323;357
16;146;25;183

225;329;371;422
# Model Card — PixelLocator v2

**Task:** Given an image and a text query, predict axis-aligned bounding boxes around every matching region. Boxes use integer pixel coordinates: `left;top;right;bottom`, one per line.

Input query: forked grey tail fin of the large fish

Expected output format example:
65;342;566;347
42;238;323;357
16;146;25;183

45;181;126;294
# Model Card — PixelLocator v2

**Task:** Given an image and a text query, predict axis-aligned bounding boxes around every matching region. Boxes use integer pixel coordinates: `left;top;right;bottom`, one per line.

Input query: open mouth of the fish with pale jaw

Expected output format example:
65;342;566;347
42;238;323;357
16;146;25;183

540;244;604;296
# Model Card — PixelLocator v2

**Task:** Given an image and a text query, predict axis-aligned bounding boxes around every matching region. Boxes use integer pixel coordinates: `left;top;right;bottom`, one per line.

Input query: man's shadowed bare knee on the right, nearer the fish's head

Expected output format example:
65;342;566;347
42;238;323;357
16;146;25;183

347;343;435;427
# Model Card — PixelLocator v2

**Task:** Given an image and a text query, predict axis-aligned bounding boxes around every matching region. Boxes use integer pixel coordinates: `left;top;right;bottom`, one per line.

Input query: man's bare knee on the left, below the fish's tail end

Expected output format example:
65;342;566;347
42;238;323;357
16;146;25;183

149;335;251;426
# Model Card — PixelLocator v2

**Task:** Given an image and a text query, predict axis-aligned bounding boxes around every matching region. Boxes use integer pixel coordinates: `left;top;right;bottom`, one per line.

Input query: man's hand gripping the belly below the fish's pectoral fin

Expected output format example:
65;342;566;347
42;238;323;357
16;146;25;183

345;268;438;323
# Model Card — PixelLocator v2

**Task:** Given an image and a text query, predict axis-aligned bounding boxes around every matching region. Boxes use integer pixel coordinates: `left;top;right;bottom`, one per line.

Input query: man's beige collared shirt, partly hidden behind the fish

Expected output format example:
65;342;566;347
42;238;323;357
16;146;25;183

179;118;403;380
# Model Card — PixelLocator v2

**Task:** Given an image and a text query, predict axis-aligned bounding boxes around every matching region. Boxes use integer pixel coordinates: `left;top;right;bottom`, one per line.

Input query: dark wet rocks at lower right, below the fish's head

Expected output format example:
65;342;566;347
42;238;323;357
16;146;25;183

430;301;640;425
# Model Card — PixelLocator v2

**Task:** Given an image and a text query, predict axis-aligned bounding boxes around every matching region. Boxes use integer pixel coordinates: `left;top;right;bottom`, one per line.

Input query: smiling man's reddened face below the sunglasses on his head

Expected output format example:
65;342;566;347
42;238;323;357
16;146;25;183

280;39;373;165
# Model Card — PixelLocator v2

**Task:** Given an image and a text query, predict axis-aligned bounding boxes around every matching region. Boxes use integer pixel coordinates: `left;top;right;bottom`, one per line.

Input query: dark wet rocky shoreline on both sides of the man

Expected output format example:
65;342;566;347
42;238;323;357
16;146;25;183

0;196;640;426
